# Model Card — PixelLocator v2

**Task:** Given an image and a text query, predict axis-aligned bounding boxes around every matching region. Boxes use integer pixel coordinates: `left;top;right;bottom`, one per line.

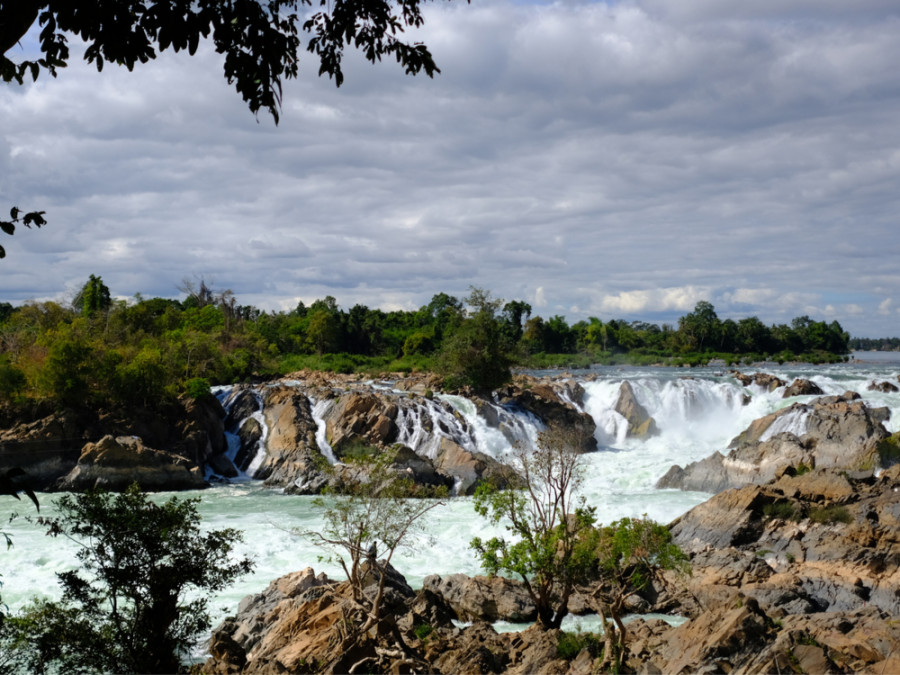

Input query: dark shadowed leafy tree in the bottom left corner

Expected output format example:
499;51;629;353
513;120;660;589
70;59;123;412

7;485;252;673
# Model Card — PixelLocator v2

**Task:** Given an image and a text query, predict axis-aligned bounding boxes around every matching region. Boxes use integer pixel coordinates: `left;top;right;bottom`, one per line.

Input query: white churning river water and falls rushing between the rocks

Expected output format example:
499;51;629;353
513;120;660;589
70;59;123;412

0;360;900;644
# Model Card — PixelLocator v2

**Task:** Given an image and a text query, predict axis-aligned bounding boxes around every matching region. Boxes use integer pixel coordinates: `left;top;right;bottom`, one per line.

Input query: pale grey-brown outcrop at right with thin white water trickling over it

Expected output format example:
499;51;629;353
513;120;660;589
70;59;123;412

657;392;892;492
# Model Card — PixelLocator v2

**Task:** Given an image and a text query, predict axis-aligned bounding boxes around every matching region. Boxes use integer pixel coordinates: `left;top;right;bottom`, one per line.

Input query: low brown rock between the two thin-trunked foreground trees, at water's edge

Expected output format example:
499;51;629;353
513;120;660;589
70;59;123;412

422;574;537;623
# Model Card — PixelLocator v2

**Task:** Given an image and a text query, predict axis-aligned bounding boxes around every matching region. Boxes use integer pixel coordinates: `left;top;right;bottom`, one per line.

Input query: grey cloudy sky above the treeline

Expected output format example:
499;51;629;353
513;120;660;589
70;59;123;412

0;0;900;337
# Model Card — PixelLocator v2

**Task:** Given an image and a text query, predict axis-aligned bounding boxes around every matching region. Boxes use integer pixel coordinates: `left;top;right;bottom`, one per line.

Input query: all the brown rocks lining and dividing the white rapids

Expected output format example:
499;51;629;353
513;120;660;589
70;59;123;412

0;372;900;675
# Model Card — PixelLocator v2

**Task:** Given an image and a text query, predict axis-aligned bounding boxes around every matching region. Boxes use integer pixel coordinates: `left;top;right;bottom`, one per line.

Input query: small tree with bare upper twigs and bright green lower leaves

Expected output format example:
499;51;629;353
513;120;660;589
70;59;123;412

471;432;596;629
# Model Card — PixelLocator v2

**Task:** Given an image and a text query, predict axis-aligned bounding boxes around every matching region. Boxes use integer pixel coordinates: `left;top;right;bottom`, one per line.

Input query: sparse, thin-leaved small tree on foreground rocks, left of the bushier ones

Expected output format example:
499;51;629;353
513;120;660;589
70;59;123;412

299;451;444;649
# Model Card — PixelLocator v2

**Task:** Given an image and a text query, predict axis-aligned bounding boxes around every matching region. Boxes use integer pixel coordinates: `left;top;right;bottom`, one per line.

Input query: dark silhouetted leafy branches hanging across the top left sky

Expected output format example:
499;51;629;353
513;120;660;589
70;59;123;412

0;0;450;123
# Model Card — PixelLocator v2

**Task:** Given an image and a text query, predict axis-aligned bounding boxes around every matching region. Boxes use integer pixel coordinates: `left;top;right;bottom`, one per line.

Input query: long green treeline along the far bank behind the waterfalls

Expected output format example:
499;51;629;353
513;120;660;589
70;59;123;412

0;275;849;407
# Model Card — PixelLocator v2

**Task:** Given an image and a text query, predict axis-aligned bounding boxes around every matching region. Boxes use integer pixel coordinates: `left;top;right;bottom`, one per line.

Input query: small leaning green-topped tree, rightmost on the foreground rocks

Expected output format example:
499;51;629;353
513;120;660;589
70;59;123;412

591;516;688;673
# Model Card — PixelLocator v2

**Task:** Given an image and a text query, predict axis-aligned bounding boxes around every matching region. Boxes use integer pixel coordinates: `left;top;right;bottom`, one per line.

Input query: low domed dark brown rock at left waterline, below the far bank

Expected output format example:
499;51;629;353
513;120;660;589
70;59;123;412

56;436;206;492
